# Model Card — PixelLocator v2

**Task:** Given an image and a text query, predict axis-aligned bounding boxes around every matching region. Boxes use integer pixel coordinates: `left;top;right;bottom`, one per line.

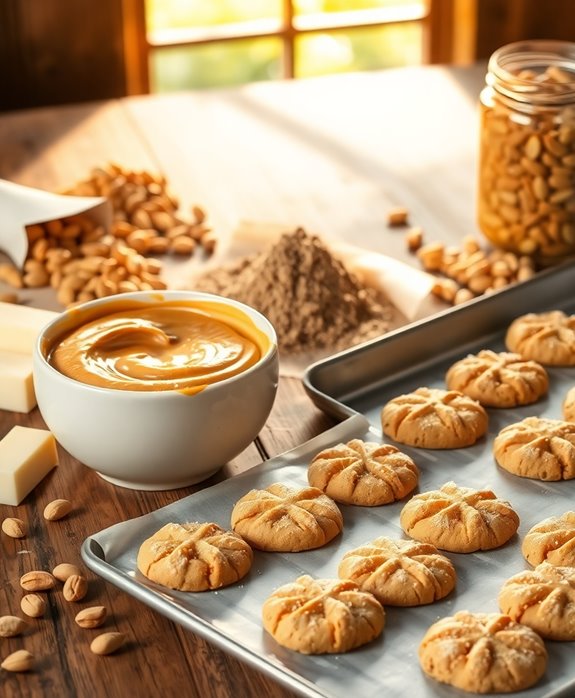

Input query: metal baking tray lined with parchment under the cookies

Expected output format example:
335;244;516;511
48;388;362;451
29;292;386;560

82;264;575;698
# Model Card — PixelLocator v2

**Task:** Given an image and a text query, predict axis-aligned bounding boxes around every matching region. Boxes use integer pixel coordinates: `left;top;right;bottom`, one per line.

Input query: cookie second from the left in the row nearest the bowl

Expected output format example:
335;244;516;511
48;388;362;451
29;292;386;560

231;483;343;552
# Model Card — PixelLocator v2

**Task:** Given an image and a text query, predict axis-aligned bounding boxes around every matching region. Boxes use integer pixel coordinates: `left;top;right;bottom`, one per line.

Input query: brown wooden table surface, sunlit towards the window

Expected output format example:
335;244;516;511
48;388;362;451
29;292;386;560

0;65;484;698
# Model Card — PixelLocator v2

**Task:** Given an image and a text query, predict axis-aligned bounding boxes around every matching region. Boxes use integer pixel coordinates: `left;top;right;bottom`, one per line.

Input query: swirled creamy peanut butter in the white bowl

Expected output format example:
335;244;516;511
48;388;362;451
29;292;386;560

47;301;270;394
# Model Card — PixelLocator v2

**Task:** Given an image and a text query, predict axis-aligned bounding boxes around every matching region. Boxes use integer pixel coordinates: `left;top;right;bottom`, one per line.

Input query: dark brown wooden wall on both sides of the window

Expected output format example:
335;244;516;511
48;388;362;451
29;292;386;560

0;0;575;111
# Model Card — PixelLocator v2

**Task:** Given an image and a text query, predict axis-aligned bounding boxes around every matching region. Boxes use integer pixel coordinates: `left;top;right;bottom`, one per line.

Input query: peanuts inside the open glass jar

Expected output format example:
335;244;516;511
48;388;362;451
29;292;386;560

479;66;575;259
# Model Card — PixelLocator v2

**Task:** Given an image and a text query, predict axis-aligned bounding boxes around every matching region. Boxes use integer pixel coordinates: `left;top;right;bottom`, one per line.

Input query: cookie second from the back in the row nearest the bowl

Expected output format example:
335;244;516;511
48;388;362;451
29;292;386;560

445;349;549;407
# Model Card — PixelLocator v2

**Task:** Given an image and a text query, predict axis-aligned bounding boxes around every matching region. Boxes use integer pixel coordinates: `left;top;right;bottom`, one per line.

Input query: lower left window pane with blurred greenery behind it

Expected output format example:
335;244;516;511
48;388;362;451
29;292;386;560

150;38;281;92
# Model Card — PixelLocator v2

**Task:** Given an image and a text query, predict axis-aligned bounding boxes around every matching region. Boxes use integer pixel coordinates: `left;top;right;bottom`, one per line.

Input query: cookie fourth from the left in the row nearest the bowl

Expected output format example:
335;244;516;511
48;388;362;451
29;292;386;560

381;387;487;448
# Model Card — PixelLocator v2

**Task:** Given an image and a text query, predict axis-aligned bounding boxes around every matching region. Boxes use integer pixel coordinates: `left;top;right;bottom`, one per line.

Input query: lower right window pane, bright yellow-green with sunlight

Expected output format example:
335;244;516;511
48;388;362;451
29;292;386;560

295;22;422;77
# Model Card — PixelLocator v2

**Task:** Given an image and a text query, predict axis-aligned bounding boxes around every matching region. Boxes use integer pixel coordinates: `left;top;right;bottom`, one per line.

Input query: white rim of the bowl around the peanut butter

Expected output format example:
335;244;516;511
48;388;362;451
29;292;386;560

33;289;278;400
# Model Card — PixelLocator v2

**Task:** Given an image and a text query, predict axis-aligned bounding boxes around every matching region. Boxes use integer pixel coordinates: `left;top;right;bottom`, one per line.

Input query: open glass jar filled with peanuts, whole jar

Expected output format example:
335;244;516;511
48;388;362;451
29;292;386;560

477;40;575;264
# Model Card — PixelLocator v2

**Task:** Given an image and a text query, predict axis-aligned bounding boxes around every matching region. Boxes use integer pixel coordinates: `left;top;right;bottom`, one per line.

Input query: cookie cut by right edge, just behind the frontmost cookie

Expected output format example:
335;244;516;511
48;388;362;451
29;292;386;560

499;562;575;641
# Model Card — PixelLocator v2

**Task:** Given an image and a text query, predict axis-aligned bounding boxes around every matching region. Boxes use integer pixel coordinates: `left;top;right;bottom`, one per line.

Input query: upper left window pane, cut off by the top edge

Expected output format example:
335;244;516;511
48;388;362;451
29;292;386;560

145;0;282;32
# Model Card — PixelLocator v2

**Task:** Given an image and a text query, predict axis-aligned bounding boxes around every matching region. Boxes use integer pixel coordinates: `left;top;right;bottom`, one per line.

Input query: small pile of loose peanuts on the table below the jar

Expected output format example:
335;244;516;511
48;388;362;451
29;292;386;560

405;227;536;305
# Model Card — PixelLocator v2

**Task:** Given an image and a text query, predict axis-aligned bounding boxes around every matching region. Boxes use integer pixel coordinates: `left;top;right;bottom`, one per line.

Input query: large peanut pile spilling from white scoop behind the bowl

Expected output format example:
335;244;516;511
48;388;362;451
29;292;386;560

0;164;216;307
